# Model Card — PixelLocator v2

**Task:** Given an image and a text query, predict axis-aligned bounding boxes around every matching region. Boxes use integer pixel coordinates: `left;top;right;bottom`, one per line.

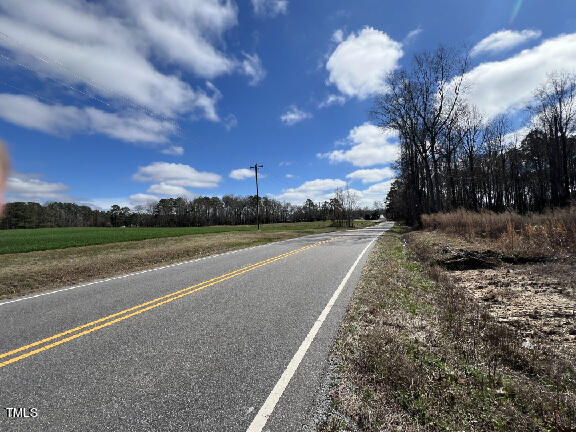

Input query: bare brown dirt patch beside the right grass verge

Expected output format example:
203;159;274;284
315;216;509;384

408;231;576;372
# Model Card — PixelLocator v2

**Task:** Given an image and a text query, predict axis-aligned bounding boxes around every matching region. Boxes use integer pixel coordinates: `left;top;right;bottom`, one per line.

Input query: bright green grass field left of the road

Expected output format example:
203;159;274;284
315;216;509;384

0;222;362;254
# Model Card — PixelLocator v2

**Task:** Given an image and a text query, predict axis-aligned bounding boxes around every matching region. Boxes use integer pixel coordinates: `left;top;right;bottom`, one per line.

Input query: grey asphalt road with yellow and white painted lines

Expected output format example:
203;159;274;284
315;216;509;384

0;224;388;432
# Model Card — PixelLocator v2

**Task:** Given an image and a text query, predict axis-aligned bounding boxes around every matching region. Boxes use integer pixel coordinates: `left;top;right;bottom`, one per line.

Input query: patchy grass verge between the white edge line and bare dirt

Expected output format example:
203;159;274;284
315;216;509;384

318;227;576;432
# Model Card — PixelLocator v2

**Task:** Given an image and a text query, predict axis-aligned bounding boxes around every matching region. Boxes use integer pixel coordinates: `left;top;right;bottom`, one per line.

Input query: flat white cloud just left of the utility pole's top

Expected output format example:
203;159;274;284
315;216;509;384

132;162;222;188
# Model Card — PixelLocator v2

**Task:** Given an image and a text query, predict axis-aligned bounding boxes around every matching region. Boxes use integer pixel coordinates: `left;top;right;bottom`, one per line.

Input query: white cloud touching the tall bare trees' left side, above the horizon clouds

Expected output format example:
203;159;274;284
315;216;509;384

318;123;399;167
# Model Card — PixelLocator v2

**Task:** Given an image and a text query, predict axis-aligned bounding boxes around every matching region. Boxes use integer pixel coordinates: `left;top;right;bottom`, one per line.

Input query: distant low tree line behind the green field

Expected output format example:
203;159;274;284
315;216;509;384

0;190;383;229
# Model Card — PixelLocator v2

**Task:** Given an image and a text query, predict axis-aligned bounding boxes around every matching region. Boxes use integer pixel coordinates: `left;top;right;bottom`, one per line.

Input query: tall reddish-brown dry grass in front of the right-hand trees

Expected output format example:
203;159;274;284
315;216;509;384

422;207;576;254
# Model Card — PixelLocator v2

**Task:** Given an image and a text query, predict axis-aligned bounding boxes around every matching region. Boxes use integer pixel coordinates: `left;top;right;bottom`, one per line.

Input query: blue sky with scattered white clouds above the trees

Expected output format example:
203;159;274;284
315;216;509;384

0;0;576;208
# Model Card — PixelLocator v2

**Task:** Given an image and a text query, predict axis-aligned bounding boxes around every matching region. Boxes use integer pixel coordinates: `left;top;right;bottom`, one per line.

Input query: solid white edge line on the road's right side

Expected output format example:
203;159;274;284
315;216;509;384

246;231;379;432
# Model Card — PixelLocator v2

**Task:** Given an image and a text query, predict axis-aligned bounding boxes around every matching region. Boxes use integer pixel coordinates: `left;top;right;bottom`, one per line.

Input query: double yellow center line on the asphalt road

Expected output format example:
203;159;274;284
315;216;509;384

0;237;340;368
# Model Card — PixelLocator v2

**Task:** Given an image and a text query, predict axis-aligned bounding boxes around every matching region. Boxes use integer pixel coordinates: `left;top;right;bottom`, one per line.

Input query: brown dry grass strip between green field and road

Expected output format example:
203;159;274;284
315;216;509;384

0;222;372;299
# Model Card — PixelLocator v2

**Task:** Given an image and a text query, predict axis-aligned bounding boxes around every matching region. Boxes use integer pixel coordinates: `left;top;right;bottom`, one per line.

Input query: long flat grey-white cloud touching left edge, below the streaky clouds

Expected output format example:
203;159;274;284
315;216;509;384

0;93;175;143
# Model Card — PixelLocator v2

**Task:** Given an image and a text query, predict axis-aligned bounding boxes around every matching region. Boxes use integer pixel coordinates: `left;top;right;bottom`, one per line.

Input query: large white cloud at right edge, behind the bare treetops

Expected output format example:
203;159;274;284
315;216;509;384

465;33;576;120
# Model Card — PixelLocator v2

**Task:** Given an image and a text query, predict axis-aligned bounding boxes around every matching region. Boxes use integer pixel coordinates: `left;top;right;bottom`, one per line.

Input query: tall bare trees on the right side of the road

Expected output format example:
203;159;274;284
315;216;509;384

371;47;576;223
